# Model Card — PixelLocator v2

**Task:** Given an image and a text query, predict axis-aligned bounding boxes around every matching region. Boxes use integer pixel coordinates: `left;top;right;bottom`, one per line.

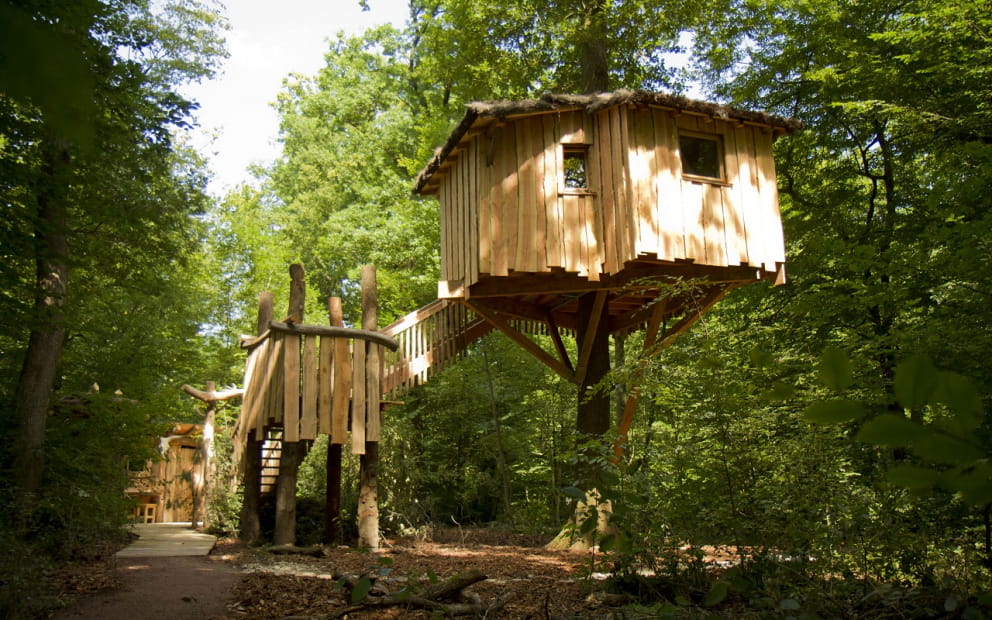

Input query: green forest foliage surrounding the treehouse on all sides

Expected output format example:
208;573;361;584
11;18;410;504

0;0;992;618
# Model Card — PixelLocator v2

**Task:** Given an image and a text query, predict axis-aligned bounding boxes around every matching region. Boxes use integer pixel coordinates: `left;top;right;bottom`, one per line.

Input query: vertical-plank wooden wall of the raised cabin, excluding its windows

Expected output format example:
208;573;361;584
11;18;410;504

438;106;785;297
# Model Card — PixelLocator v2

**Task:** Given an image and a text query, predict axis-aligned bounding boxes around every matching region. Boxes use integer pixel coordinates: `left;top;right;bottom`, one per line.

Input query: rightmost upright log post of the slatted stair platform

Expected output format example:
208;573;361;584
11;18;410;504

352;265;381;549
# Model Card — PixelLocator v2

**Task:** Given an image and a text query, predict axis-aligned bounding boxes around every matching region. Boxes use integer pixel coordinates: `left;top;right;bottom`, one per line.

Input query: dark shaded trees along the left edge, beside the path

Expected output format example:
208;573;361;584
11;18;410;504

0;0;231;617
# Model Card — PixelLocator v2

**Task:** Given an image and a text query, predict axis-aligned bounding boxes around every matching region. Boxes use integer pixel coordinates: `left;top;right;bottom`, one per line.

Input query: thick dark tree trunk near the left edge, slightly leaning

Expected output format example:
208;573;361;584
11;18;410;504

14;143;69;493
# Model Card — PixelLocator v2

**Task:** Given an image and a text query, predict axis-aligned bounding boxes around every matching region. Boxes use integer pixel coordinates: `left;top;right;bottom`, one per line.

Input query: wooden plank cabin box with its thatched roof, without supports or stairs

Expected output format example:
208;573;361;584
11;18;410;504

416;92;799;299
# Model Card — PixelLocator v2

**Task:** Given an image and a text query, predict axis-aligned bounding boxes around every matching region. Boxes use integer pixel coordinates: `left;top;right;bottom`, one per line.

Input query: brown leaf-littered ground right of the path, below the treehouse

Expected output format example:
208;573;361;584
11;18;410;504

228;532;602;620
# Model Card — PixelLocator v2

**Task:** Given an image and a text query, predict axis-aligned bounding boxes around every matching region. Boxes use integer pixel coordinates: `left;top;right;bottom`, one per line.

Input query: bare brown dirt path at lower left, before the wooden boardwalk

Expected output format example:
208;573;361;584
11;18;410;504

55;556;241;620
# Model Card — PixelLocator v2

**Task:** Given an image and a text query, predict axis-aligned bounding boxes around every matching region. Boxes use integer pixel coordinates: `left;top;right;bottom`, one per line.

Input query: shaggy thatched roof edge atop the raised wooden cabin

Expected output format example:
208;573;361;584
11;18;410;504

413;90;803;193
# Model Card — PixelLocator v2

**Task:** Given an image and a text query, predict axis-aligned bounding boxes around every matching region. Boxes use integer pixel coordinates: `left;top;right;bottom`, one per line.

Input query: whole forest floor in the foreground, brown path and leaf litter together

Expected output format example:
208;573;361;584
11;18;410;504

52;529;605;620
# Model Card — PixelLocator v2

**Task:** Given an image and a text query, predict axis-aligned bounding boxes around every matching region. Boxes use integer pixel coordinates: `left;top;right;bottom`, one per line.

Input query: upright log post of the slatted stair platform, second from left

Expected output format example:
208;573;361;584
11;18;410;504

272;263;306;545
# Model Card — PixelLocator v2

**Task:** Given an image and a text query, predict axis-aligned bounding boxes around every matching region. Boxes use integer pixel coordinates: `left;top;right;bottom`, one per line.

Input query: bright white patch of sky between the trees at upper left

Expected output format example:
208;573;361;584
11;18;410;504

186;0;409;194
